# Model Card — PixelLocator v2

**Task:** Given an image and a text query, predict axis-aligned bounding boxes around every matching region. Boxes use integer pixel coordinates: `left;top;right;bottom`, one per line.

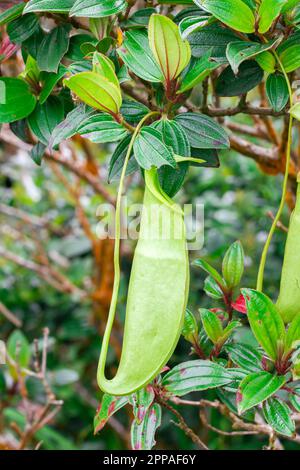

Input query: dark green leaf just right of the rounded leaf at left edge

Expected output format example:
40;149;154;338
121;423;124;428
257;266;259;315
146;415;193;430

28;96;64;145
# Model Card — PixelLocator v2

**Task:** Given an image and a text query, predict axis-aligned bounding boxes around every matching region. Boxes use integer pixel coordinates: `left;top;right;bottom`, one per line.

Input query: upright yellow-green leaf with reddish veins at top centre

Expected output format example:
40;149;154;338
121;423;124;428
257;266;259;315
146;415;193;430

148;14;191;83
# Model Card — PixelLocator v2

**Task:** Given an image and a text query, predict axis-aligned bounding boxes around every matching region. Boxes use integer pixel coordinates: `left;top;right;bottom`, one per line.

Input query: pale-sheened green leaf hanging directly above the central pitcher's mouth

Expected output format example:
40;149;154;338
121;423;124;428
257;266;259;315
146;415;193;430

133;126;176;170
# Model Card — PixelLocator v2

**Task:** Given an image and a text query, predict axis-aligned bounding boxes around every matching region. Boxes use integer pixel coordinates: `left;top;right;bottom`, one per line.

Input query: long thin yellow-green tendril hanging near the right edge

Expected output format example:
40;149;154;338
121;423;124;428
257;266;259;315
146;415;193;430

256;51;293;292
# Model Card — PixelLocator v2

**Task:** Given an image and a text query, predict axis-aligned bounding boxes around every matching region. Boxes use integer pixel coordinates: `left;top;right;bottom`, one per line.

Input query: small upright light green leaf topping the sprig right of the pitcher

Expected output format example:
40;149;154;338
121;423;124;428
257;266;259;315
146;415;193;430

222;241;244;289
